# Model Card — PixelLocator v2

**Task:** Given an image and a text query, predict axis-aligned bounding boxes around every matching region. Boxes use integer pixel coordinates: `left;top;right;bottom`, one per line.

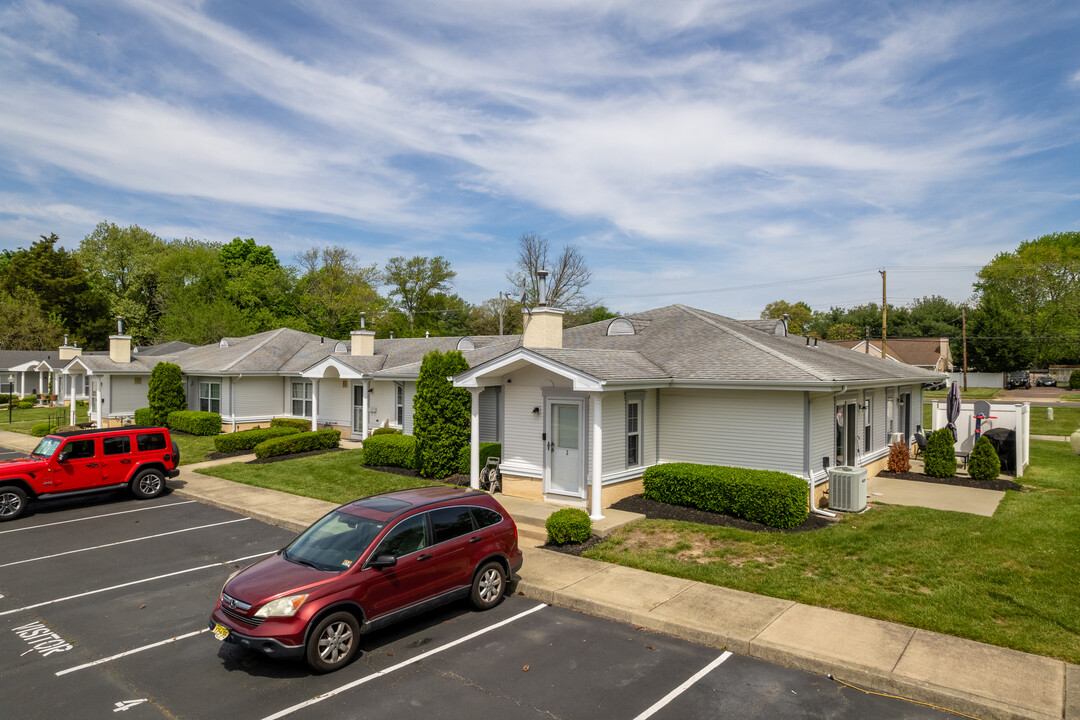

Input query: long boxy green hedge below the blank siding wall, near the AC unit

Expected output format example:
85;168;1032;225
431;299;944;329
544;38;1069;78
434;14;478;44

642;462;810;530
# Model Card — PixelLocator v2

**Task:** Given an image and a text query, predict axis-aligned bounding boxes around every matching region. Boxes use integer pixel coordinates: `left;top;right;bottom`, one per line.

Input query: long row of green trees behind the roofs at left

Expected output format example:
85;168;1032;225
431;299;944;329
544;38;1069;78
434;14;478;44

0;222;616;350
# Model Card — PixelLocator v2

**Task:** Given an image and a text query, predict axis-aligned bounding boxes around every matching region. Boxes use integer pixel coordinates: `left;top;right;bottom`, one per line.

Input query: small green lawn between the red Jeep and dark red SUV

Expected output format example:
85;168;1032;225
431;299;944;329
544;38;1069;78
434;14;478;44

196;450;438;503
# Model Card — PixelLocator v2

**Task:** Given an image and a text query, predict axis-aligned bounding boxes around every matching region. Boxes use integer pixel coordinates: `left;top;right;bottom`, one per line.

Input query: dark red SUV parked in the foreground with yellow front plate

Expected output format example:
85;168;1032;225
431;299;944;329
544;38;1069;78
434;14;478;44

210;486;522;673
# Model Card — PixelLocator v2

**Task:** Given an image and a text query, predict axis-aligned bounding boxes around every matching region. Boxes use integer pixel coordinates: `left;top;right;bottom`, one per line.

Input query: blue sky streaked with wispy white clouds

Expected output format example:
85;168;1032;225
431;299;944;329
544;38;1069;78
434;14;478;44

0;0;1080;317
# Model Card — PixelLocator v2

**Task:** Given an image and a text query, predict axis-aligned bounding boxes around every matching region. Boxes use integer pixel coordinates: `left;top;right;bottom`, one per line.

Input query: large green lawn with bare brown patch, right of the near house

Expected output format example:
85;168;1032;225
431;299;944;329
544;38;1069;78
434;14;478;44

586;440;1080;663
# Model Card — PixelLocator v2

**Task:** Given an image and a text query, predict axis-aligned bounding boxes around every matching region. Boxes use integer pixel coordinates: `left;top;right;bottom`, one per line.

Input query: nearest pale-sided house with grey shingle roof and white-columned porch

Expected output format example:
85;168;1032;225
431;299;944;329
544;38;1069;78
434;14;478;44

454;305;943;517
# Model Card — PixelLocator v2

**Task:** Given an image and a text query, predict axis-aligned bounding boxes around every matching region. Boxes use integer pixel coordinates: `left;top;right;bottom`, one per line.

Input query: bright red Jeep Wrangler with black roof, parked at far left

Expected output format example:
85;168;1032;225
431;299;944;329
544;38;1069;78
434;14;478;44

0;425;180;522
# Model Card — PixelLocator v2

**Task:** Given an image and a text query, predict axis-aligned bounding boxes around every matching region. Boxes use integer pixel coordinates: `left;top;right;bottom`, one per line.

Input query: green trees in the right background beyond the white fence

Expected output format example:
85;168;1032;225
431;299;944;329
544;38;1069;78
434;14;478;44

761;232;1080;372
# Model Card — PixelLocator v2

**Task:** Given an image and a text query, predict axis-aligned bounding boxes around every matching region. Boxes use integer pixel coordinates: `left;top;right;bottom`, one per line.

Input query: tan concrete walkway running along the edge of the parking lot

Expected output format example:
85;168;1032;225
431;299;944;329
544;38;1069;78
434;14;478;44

0;432;1080;720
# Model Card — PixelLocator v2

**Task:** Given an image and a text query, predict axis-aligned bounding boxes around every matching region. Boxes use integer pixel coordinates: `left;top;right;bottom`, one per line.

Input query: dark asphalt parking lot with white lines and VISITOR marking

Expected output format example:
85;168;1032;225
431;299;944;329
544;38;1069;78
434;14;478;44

0;493;950;720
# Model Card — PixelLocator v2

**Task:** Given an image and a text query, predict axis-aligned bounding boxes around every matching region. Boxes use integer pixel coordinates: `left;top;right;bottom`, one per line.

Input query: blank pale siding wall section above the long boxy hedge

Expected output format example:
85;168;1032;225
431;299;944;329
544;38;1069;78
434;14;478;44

646;390;804;475
